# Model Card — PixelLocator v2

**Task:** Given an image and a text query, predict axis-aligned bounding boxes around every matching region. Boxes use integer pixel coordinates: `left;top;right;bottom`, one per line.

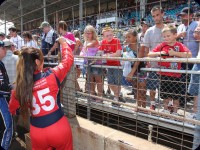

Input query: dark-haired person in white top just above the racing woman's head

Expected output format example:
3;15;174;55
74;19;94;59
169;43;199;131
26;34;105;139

23;31;38;48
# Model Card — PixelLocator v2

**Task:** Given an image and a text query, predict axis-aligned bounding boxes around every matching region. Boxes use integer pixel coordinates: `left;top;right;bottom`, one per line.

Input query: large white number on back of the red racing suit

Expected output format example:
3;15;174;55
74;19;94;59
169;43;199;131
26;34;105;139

32;88;55;115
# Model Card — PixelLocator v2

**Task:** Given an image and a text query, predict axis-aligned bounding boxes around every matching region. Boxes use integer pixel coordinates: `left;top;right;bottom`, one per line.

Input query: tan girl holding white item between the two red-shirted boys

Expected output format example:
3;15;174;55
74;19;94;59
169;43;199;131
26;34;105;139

121;29;146;108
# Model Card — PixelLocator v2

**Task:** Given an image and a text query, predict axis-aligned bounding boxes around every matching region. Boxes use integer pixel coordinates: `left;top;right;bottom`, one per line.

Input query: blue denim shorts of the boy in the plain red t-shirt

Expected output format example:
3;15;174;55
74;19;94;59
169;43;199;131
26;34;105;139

107;68;123;85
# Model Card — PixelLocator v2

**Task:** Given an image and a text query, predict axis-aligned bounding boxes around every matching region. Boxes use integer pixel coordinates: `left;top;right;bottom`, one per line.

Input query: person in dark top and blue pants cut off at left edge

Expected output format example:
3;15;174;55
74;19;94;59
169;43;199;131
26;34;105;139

0;41;13;150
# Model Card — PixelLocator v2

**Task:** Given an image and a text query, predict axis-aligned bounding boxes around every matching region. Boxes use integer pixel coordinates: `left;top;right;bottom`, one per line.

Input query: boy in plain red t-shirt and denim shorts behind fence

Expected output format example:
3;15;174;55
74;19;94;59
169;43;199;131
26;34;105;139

99;27;122;106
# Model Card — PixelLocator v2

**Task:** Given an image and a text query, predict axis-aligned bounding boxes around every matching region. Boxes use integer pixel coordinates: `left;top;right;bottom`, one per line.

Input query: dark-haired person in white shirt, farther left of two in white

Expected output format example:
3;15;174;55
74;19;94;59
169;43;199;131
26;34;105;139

8;26;24;50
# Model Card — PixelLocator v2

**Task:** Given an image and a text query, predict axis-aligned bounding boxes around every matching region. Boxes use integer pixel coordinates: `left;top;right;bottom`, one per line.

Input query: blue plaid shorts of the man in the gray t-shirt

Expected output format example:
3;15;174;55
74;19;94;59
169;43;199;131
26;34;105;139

147;72;159;90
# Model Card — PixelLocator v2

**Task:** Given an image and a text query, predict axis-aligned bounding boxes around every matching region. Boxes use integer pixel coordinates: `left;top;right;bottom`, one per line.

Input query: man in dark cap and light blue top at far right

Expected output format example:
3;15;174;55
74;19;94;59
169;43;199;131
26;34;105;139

177;7;199;107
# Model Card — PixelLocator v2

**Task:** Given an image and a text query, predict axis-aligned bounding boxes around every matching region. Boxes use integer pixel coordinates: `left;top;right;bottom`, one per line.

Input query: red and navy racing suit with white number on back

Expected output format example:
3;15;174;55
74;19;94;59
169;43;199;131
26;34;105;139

9;43;74;150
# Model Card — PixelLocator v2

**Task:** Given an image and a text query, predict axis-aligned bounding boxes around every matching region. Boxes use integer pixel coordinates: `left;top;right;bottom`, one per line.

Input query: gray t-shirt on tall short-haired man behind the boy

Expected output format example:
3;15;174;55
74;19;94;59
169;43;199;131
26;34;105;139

142;26;163;51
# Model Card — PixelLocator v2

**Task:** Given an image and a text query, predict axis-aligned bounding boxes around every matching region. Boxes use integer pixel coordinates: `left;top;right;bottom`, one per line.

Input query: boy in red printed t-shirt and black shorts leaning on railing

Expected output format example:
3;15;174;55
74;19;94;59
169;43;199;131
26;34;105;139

148;25;192;115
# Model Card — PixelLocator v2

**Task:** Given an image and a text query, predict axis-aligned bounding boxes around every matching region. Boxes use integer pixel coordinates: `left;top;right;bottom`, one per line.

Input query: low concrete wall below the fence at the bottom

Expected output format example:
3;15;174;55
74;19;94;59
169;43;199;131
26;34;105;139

69;117;170;150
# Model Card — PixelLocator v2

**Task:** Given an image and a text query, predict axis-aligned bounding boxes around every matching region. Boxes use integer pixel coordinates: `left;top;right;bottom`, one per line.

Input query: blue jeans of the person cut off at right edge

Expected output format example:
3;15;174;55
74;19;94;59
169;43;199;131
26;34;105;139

188;64;200;96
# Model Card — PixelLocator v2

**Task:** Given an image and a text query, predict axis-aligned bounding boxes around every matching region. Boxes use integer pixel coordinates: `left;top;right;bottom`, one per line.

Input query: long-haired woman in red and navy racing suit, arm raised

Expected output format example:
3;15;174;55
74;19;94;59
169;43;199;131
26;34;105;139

9;37;74;150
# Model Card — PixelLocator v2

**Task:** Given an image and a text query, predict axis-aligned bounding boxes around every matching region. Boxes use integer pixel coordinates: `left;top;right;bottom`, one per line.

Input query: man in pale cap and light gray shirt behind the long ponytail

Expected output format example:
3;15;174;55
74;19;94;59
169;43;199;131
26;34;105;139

2;39;18;84
